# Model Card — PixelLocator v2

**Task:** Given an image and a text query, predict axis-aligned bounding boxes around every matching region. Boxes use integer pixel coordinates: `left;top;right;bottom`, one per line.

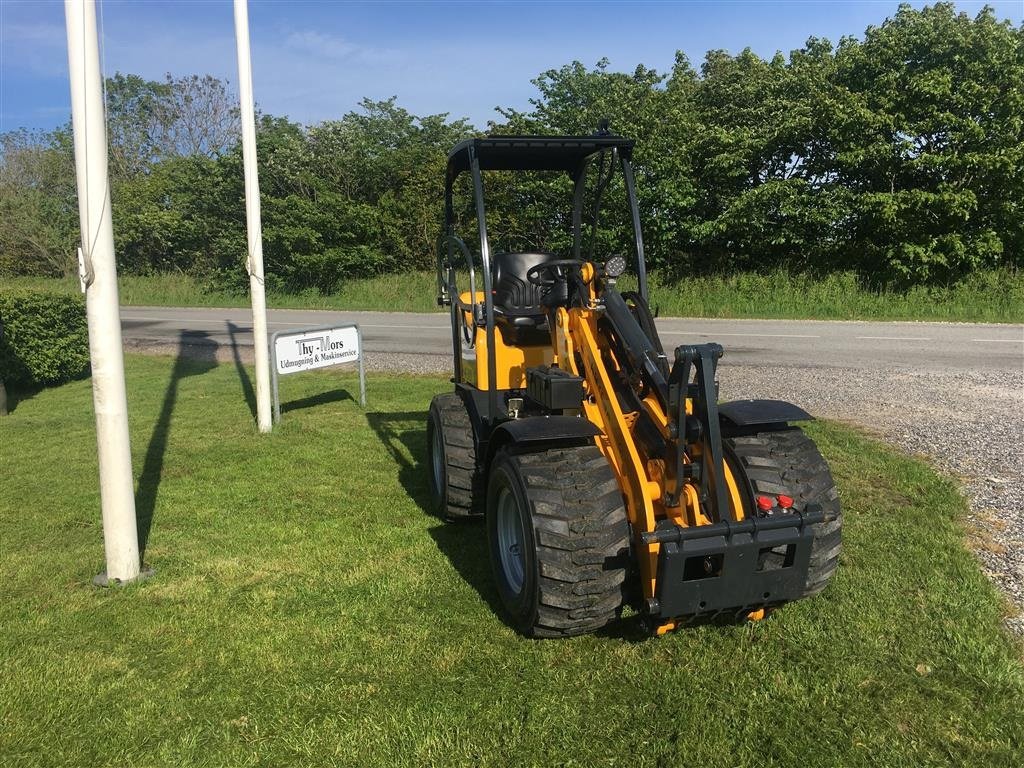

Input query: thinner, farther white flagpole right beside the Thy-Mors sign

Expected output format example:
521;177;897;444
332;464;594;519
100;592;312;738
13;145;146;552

234;0;271;432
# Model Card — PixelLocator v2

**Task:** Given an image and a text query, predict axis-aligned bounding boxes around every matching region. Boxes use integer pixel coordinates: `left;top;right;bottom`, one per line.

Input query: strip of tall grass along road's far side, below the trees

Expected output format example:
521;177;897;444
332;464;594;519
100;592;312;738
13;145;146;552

10;270;1024;323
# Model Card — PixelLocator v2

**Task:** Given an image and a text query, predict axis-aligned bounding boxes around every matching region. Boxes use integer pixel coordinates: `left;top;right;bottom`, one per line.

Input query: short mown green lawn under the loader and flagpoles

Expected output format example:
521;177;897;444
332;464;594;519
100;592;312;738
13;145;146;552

0;356;1024;768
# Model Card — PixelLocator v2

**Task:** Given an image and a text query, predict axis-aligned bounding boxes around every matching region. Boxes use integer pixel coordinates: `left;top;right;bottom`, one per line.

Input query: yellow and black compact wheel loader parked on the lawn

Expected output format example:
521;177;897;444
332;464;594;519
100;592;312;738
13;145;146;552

427;129;842;637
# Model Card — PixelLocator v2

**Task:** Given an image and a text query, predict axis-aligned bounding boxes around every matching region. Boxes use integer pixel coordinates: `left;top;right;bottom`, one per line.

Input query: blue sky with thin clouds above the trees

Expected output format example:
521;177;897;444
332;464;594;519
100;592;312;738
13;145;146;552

0;0;1024;131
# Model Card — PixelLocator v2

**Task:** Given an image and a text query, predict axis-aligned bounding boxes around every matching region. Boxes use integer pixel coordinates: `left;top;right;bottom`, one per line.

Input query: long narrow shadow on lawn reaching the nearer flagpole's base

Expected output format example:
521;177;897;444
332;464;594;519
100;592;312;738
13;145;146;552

135;331;217;557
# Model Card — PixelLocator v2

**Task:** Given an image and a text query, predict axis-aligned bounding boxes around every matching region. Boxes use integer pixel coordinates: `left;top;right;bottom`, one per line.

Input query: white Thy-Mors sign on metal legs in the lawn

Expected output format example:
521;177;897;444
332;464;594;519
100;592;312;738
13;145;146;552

270;325;367;421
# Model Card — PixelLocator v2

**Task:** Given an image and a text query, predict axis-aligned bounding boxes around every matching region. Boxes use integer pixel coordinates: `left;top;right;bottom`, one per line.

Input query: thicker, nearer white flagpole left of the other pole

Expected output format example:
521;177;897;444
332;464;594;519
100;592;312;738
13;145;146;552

65;0;139;584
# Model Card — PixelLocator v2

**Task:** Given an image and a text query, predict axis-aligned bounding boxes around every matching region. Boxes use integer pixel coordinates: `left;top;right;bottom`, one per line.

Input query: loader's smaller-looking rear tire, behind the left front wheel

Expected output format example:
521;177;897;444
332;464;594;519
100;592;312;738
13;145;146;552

427;392;483;520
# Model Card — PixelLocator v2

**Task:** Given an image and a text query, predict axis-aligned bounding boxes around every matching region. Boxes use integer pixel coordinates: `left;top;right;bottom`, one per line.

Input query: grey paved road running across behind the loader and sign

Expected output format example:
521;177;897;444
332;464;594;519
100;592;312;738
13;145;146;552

121;307;1024;372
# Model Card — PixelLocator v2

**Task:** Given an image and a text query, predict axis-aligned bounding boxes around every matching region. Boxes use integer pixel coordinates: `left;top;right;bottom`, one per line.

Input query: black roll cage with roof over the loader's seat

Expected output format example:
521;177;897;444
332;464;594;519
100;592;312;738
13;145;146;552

437;133;647;423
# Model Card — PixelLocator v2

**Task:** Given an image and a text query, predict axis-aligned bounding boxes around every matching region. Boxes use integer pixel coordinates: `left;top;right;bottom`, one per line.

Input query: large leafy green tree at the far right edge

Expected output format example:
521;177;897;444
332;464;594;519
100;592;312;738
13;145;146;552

833;3;1024;282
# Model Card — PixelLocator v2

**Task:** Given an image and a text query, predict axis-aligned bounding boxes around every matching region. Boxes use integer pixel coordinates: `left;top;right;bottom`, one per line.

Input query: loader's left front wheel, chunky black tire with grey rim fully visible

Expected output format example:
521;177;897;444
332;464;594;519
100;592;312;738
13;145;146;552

486;445;630;637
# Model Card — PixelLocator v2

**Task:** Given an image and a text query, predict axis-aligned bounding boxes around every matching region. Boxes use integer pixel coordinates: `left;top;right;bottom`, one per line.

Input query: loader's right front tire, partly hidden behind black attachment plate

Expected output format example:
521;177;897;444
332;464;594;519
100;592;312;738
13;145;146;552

724;427;843;597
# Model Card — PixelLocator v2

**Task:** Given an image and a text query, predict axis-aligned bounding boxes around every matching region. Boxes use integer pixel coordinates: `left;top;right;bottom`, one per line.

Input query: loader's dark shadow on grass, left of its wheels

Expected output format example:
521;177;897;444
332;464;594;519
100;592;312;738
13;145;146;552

367;411;506;622
